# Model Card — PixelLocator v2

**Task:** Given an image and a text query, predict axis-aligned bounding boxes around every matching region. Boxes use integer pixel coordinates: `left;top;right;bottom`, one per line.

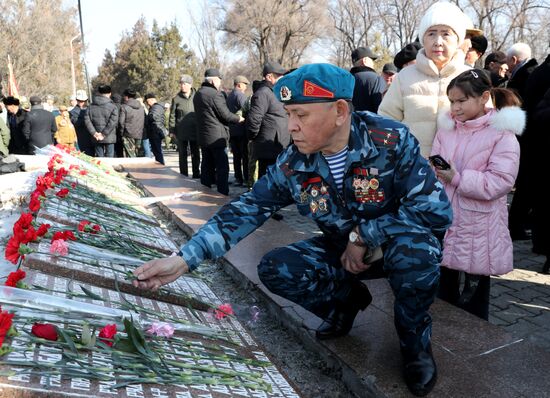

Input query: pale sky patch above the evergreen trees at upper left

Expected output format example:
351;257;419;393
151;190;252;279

75;0;201;76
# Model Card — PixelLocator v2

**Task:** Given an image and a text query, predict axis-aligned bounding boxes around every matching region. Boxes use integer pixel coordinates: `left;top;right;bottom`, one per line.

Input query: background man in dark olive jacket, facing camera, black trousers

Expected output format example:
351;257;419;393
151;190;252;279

168;75;201;178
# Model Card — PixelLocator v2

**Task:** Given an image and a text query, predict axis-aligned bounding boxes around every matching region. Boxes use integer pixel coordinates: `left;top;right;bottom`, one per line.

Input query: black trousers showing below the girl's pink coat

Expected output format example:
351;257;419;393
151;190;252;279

437;267;491;321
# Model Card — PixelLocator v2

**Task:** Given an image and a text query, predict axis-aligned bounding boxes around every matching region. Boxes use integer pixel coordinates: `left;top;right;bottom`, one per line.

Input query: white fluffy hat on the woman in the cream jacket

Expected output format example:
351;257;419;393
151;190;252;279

418;1;472;45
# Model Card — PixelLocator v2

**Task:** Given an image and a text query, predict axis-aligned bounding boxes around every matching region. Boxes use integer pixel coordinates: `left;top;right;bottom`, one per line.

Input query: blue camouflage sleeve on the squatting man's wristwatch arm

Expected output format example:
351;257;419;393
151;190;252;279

360;129;452;247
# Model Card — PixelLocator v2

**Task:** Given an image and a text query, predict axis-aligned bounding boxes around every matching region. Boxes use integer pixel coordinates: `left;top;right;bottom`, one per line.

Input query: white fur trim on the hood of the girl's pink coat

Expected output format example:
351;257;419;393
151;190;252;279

437;106;527;136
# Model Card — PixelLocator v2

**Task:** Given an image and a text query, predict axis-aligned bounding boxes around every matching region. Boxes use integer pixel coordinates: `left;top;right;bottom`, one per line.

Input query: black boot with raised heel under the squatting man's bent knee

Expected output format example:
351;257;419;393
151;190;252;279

315;281;372;340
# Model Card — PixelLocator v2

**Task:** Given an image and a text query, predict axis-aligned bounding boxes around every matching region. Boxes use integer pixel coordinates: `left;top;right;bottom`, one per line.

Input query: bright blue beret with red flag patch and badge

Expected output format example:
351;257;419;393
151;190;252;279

273;64;355;104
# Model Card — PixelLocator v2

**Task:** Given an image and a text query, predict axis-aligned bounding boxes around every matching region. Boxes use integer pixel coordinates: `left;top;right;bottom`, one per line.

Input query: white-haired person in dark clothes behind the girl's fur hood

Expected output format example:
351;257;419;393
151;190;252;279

506;43;537;240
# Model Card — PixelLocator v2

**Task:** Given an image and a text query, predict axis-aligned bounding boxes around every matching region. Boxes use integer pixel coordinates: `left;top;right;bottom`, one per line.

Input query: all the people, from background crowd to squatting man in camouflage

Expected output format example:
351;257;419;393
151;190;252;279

0;2;550;396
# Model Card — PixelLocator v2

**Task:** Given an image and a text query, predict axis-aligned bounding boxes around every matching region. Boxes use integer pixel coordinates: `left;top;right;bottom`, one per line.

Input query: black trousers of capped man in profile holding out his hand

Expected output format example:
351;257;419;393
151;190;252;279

201;147;229;195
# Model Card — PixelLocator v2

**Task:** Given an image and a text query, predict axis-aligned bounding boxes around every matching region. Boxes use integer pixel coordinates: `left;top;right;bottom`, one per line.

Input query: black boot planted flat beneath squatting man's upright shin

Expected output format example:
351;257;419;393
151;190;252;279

403;346;437;397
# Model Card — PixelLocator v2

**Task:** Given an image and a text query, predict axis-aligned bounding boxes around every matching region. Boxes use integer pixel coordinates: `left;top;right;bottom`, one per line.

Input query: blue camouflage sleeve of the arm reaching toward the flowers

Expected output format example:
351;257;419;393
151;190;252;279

178;165;293;271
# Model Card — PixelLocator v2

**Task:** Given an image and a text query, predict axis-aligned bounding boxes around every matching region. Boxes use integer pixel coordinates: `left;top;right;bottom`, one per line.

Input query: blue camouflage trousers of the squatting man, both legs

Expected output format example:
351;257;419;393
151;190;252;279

258;234;441;353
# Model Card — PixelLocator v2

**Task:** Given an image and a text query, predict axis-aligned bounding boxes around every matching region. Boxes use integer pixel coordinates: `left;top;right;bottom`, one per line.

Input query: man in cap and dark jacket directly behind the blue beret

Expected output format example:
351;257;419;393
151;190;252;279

246;62;290;179
